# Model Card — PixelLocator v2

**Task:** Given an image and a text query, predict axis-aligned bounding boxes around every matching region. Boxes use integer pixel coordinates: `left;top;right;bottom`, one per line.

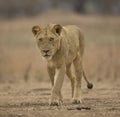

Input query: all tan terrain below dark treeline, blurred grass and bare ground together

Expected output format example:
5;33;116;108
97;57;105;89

0;10;120;117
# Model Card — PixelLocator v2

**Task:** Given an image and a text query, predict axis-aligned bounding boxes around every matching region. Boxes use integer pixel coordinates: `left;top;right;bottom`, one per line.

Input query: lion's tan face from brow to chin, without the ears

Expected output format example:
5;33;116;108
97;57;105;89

36;31;60;58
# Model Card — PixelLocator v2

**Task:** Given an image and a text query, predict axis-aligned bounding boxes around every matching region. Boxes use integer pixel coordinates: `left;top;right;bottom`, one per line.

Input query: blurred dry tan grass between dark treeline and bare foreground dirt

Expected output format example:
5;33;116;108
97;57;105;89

0;11;120;82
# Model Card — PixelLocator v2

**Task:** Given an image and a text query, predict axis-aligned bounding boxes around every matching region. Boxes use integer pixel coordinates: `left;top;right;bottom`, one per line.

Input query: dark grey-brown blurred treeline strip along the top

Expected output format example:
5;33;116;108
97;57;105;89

0;0;120;18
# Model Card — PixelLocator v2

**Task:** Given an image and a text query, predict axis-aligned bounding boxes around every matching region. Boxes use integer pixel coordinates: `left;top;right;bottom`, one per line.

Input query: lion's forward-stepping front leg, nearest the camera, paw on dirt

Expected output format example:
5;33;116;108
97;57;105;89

50;65;65;106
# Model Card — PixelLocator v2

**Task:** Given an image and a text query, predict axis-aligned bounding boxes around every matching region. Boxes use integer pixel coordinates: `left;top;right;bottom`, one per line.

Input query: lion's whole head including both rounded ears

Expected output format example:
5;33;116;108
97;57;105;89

32;24;62;59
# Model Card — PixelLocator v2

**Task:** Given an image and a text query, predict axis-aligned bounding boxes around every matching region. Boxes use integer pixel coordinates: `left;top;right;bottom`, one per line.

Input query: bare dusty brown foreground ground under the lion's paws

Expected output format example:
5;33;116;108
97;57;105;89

0;81;120;117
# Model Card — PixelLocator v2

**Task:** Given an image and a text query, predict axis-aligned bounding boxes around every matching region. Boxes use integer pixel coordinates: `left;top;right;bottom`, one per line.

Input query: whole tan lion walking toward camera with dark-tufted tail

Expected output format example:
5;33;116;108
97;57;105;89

32;24;93;106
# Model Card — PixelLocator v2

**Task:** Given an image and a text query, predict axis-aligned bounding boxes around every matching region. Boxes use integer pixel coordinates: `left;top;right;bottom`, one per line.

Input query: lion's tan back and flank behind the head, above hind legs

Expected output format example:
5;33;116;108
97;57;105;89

63;25;84;61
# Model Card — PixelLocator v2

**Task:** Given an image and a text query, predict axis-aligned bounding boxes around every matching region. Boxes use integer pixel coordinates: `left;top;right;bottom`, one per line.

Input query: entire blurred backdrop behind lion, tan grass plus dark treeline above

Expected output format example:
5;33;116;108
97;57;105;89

0;0;120;83
